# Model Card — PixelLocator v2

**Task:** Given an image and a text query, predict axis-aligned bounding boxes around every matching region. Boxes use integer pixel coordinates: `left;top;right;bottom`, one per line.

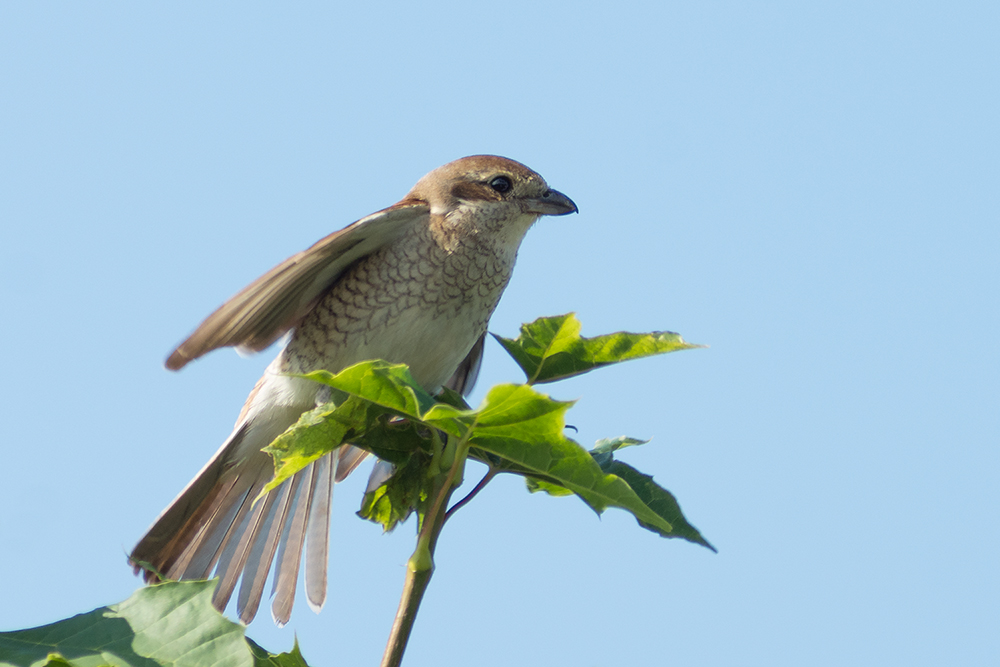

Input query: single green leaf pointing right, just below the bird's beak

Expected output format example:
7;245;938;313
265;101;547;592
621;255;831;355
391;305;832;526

493;313;704;384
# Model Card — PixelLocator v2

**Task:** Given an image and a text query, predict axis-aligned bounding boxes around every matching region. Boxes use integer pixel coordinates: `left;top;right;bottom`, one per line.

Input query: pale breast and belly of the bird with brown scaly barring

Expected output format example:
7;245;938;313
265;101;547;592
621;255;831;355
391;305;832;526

282;226;517;391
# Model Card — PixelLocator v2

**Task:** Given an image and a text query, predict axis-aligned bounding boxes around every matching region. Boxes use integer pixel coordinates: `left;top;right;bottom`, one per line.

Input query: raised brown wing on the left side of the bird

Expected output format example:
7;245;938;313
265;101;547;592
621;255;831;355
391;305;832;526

167;204;430;370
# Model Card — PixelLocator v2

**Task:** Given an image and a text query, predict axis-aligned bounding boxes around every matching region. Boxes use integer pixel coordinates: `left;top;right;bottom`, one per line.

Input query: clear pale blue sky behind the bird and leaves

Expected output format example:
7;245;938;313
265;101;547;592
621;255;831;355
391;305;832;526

0;1;1000;667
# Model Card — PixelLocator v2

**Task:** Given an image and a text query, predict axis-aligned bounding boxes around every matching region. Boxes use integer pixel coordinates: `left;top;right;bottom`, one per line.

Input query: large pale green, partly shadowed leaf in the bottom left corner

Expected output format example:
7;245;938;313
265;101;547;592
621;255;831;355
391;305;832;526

0;581;253;667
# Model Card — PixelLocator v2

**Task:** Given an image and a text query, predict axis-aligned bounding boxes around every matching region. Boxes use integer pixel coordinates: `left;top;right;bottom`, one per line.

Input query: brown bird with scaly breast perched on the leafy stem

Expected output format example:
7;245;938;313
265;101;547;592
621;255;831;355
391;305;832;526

129;155;578;626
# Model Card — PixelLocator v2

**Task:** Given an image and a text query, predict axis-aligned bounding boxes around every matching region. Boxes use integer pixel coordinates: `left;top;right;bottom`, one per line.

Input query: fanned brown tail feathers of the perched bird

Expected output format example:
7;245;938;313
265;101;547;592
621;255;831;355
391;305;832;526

129;419;342;626
